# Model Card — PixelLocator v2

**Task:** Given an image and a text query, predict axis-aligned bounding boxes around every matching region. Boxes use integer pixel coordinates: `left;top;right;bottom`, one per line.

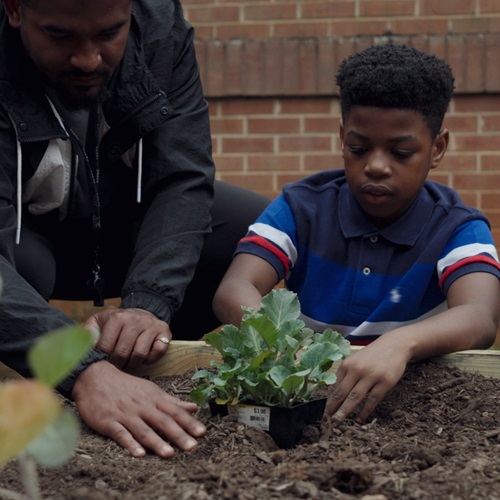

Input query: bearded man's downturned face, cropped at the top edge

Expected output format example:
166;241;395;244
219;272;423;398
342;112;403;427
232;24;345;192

4;0;132;105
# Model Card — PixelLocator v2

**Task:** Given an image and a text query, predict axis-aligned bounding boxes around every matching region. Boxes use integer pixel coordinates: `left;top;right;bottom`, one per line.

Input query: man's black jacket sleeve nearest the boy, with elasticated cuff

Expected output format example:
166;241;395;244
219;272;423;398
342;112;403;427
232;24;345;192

121;2;215;322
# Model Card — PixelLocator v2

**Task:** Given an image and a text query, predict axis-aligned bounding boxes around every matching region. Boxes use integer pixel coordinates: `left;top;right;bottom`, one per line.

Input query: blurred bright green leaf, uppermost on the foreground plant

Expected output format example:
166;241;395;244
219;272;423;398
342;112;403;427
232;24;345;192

28;326;93;387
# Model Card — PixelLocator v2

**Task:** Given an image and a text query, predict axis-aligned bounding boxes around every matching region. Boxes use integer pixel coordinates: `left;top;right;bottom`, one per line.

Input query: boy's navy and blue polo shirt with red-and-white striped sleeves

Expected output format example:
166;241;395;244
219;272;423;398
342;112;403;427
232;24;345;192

236;170;500;344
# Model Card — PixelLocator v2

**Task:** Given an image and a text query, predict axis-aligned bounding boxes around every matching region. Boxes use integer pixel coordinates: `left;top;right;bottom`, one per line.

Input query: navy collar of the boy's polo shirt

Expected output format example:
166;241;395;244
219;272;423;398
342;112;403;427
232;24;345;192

338;183;434;246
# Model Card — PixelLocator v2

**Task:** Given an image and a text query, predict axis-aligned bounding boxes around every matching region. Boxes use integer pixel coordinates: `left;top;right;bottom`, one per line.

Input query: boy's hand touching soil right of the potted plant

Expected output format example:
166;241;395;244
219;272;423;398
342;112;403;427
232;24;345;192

326;333;409;423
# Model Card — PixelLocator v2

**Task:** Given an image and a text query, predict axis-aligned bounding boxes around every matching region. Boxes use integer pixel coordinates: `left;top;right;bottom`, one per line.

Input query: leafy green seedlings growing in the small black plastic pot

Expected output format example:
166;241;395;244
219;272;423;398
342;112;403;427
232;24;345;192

190;288;350;407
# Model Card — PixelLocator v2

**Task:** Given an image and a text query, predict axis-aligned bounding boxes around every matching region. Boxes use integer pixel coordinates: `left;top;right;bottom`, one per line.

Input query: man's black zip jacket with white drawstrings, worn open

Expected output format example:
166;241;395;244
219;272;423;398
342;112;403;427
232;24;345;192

0;0;214;386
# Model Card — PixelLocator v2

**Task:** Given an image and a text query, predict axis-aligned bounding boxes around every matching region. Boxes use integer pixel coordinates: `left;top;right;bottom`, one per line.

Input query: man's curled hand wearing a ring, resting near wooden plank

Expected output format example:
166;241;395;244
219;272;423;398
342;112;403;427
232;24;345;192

85;309;172;371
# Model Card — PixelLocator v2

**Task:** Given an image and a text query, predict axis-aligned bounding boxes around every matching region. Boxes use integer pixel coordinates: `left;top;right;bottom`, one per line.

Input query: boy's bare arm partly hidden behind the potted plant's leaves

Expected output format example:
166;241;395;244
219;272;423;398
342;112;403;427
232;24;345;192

213;253;278;326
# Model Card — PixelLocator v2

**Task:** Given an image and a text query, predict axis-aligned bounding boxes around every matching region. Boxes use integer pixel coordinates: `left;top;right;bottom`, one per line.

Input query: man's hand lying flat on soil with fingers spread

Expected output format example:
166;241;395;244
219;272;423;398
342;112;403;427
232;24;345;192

72;361;206;458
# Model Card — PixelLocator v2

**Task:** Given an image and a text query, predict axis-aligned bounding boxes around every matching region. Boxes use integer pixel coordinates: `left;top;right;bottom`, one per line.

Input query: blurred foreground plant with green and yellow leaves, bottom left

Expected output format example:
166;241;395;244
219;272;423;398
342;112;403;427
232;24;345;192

0;327;93;500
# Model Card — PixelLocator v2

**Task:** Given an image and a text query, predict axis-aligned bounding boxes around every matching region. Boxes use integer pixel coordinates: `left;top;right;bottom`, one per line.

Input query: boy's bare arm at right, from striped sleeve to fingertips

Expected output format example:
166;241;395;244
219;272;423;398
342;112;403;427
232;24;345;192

326;272;500;423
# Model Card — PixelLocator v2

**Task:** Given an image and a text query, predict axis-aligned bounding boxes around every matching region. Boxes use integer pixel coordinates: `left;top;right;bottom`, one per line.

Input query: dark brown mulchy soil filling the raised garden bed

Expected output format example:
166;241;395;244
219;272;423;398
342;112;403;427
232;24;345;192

0;362;500;500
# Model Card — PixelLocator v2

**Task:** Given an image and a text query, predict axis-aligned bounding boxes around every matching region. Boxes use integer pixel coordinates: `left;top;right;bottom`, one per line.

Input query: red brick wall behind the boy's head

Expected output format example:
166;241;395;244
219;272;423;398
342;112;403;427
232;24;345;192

183;0;500;246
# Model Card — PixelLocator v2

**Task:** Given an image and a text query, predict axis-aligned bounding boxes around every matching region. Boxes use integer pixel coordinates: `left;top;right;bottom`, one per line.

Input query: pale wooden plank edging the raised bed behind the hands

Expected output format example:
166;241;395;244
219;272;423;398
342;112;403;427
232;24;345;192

0;340;500;379
